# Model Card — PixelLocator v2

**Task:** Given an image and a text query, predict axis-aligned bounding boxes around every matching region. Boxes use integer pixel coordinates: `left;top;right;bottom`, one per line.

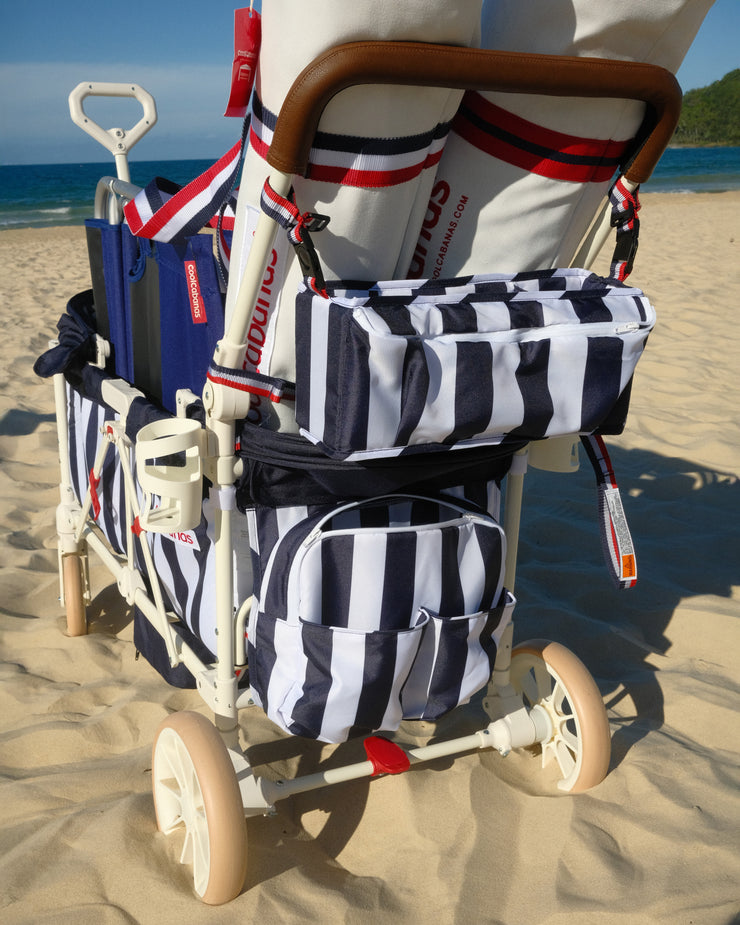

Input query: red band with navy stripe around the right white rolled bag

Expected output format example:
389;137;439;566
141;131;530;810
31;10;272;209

452;92;627;183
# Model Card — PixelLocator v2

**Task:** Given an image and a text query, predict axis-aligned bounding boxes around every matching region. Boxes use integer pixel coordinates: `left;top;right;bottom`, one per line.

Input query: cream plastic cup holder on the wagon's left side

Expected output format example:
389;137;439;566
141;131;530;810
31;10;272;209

136;418;203;533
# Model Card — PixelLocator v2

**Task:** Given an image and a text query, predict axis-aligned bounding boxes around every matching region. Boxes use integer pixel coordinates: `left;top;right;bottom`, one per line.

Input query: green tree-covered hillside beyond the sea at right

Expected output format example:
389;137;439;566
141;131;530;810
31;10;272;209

673;68;740;145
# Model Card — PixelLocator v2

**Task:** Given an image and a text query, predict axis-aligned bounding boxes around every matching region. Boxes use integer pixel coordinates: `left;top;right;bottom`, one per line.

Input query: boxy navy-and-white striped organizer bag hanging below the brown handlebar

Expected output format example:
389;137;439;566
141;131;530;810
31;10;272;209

296;269;655;459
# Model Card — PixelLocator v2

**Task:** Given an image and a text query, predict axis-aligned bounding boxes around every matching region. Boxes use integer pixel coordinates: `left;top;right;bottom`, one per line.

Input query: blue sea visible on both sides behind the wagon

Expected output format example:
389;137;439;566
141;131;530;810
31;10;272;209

0;147;740;230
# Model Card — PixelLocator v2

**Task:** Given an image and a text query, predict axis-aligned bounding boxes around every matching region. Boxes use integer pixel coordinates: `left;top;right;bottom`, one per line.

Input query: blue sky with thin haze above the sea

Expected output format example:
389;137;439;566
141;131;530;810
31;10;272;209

0;0;740;165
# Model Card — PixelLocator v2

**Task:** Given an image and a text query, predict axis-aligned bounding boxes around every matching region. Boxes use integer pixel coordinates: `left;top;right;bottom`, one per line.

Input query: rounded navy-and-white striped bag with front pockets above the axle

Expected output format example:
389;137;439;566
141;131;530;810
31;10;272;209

249;496;513;742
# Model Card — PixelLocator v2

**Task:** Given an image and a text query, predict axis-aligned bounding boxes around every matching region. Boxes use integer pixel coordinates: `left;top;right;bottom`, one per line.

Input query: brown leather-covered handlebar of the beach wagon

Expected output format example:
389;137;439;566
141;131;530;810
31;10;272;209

267;42;681;183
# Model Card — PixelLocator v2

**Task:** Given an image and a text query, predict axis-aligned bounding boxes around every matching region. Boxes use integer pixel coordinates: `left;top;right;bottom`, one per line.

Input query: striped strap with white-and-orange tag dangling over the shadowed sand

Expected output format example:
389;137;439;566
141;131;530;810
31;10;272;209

581;434;637;590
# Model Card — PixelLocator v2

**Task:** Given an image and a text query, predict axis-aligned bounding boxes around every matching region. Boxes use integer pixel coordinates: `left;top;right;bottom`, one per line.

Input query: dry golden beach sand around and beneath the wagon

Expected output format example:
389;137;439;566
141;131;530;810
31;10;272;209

0;193;740;925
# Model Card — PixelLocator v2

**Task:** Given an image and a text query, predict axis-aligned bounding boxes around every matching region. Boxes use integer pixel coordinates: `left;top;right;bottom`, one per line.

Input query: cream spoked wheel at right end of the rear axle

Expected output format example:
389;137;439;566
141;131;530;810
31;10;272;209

511;639;611;793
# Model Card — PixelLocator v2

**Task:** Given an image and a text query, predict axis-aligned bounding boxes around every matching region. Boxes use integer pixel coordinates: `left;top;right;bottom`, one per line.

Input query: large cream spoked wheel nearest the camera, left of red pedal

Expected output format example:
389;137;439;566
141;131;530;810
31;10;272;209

152;711;247;905
